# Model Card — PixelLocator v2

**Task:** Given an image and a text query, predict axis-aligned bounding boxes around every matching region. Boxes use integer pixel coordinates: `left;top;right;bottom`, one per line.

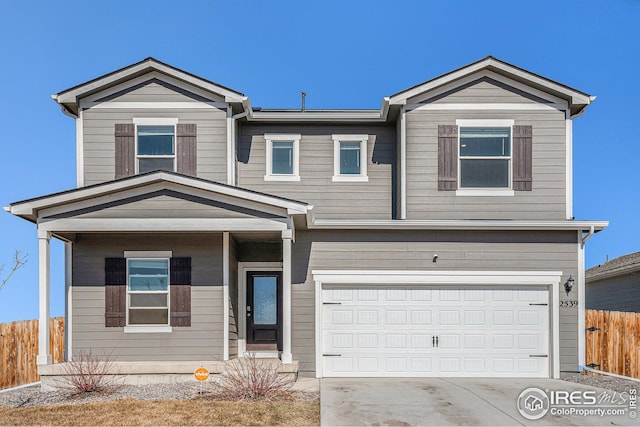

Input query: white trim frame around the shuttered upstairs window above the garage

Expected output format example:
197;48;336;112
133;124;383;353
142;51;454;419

456;119;515;197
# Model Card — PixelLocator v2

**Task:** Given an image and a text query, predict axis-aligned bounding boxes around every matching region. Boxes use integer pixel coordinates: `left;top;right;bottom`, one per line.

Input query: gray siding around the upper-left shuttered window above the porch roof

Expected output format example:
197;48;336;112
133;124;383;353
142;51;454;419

83;105;227;185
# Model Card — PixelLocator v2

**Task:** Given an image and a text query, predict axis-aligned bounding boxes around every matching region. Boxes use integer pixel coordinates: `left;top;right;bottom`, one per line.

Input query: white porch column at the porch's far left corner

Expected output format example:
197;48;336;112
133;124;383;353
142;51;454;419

36;230;51;365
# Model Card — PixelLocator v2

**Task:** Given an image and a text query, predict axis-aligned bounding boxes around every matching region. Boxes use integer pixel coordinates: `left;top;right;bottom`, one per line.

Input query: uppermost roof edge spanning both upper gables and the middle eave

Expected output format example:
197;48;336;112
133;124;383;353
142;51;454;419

53;56;595;122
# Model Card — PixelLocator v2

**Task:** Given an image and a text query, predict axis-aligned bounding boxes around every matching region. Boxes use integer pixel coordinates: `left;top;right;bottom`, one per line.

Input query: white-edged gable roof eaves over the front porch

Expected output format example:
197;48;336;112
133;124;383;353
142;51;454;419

5;171;312;222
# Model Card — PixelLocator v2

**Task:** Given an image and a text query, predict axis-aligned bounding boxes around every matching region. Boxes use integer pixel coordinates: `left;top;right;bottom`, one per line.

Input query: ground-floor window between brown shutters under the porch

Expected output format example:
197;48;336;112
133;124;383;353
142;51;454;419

127;258;169;326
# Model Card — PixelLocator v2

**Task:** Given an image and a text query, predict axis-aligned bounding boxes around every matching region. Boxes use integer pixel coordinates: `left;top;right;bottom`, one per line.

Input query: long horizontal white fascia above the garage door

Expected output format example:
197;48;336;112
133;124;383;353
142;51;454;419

308;219;609;231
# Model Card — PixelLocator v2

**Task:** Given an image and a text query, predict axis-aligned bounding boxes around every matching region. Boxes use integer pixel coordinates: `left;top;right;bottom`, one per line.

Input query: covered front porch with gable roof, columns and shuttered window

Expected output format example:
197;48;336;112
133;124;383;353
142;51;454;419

6;172;311;381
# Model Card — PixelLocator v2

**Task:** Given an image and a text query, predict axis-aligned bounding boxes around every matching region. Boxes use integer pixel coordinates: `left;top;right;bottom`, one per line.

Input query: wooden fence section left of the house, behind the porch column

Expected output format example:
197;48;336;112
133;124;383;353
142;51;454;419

0;317;64;389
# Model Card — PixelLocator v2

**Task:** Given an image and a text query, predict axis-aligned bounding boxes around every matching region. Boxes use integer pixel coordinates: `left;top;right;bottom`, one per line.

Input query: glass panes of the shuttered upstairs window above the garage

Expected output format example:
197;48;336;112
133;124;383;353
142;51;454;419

460;127;511;188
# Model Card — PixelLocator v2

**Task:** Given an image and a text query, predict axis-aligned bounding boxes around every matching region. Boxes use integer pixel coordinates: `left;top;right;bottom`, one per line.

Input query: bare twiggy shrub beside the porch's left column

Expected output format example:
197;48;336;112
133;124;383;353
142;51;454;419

58;350;122;395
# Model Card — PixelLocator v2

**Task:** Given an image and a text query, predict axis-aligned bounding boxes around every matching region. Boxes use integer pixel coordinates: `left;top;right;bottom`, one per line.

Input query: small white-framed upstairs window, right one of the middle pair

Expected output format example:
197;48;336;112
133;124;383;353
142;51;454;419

333;135;369;182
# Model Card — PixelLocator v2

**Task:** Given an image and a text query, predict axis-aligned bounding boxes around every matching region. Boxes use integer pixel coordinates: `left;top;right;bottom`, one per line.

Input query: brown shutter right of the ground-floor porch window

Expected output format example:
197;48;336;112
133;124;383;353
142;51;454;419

169;258;191;326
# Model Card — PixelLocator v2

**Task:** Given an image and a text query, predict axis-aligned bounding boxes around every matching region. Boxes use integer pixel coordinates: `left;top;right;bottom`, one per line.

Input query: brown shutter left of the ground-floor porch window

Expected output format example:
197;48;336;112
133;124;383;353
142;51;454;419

104;258;127;327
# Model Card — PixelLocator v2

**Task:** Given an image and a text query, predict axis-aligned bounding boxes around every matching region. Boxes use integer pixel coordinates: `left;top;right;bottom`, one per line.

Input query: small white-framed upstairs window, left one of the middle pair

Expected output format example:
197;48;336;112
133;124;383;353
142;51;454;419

264;134;300;181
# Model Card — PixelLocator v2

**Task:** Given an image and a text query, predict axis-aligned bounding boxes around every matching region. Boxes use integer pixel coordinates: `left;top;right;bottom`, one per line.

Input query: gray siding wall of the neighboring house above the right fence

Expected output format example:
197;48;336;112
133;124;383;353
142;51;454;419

586;272;640;313
